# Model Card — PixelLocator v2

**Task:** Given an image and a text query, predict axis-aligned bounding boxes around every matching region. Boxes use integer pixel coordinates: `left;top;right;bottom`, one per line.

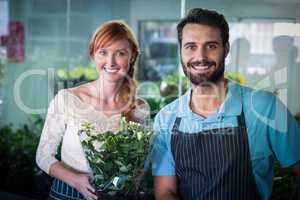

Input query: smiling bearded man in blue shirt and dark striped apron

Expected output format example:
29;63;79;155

152;8;300;200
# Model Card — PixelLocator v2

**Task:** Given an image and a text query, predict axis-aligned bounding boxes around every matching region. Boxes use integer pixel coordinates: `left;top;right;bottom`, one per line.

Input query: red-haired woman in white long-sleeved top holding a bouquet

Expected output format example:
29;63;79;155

36;21;149;200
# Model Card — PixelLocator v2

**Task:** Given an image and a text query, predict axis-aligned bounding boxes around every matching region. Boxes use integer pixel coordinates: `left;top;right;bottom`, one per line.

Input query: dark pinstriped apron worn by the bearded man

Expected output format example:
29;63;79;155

171;111;261;200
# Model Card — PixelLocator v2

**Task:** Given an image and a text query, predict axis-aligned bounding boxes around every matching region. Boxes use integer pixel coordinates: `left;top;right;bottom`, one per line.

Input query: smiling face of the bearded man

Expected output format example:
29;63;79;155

181;24;229;85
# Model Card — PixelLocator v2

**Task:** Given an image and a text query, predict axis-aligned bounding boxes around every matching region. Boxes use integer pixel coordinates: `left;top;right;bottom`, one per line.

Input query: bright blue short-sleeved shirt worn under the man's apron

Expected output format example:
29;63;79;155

152;81;300;199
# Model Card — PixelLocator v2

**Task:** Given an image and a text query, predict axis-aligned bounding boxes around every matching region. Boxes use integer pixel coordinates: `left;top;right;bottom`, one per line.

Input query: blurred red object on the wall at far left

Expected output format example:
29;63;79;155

0;21;25;63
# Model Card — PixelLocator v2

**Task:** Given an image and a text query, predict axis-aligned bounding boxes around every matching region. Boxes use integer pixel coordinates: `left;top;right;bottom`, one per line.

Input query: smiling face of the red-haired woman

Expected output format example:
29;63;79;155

94;39;132;82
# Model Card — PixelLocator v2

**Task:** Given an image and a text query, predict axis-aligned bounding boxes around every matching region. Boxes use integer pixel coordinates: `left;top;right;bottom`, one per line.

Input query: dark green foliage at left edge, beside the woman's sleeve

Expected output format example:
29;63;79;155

0;116;43;193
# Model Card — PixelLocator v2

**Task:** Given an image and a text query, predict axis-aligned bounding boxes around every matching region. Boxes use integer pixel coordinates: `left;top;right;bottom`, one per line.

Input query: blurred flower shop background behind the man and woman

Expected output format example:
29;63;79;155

0;0;300;199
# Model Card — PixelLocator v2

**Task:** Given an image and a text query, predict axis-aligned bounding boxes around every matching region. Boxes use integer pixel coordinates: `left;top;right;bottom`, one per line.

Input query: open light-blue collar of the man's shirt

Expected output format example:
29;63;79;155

177;80;242;117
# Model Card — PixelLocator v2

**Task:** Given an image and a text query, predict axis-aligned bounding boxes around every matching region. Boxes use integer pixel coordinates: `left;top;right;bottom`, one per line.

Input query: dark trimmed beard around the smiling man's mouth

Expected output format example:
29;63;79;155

181;58;225;85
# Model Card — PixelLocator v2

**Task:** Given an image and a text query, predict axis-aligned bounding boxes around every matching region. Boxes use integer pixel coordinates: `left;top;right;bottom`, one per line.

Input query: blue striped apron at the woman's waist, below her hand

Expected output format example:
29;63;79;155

48;178;85;200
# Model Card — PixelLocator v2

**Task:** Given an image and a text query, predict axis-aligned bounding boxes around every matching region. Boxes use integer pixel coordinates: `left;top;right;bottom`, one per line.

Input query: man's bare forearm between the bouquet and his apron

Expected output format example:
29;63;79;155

154;176;179;200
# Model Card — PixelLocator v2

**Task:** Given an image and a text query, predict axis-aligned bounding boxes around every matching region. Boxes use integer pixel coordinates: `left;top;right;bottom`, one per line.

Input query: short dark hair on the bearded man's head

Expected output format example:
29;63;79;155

177;8;229;48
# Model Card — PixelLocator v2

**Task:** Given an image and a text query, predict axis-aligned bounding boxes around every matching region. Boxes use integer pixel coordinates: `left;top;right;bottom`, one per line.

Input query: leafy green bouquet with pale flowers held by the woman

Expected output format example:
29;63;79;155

78;117;152;194
